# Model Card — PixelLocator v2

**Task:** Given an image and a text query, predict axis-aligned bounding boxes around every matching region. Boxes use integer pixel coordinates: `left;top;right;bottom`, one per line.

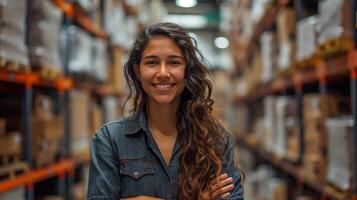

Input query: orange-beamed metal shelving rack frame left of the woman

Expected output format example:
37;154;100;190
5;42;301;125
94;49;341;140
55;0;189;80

0;0;109;200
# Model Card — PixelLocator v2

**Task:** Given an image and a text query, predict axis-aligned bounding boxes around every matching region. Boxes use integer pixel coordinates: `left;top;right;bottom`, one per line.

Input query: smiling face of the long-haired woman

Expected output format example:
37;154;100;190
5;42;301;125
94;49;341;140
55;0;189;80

138;36;186;105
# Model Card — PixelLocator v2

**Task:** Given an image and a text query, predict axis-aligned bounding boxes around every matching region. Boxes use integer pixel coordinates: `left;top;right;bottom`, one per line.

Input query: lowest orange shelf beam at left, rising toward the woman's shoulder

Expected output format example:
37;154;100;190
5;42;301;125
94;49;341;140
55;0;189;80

0;160;74;192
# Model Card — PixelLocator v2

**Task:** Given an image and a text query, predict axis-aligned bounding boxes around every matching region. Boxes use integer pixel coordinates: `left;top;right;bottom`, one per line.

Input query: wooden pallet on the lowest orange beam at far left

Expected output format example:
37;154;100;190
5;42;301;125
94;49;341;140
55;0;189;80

0;156;29;180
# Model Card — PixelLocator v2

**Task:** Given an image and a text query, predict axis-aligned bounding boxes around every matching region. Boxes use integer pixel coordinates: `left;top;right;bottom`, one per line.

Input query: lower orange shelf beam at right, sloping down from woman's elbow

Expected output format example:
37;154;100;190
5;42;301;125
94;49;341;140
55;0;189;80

237;134;352;200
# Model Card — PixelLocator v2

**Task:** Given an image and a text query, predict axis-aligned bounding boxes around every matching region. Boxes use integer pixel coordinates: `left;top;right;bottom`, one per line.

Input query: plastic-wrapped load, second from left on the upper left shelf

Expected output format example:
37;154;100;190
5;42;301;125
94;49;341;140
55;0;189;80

29;0;63;72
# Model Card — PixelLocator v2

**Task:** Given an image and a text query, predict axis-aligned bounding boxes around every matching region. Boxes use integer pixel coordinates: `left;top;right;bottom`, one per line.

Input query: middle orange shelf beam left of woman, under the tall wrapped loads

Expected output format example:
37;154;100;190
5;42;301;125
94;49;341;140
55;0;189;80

0;69;73;91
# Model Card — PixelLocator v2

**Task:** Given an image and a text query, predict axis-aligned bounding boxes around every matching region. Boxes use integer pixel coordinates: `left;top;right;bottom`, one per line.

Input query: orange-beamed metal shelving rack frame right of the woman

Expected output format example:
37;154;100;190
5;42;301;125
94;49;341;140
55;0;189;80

235;0;357;200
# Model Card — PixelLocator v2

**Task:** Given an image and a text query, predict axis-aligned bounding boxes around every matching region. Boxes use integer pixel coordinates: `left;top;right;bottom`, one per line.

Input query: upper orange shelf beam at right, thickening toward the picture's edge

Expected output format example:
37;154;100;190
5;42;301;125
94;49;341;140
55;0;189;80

235;54;353;103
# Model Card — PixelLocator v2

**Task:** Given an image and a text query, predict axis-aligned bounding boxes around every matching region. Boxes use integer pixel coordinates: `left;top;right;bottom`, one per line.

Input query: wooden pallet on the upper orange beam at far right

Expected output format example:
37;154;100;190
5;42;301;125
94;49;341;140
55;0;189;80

316;37;353;57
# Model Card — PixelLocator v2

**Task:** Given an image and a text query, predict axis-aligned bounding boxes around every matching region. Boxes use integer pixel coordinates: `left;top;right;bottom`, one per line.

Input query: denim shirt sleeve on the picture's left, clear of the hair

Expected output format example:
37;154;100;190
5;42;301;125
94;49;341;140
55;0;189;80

87;129;120;200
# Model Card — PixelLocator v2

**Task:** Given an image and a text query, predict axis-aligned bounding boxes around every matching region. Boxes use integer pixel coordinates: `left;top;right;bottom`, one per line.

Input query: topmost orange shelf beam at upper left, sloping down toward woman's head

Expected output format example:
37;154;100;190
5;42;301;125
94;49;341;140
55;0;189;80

52;0;108;39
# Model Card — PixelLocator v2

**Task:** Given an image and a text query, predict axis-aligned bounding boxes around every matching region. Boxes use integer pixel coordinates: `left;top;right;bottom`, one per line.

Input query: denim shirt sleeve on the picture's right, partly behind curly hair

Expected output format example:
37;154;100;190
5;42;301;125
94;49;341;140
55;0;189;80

217;133;244;200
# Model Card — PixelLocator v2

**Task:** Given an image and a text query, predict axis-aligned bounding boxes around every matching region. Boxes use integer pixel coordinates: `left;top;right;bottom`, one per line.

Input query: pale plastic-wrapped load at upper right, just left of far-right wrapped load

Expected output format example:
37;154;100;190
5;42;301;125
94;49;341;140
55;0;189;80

296;16;318;61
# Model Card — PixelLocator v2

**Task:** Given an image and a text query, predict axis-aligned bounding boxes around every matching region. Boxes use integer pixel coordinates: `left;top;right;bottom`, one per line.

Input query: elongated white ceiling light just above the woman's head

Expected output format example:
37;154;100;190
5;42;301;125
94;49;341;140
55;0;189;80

165;15;208;29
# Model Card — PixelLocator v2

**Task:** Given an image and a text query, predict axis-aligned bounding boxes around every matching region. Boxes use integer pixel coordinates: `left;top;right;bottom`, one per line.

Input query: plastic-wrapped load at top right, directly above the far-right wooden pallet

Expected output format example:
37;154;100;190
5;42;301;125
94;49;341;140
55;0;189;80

318;0;352;44
